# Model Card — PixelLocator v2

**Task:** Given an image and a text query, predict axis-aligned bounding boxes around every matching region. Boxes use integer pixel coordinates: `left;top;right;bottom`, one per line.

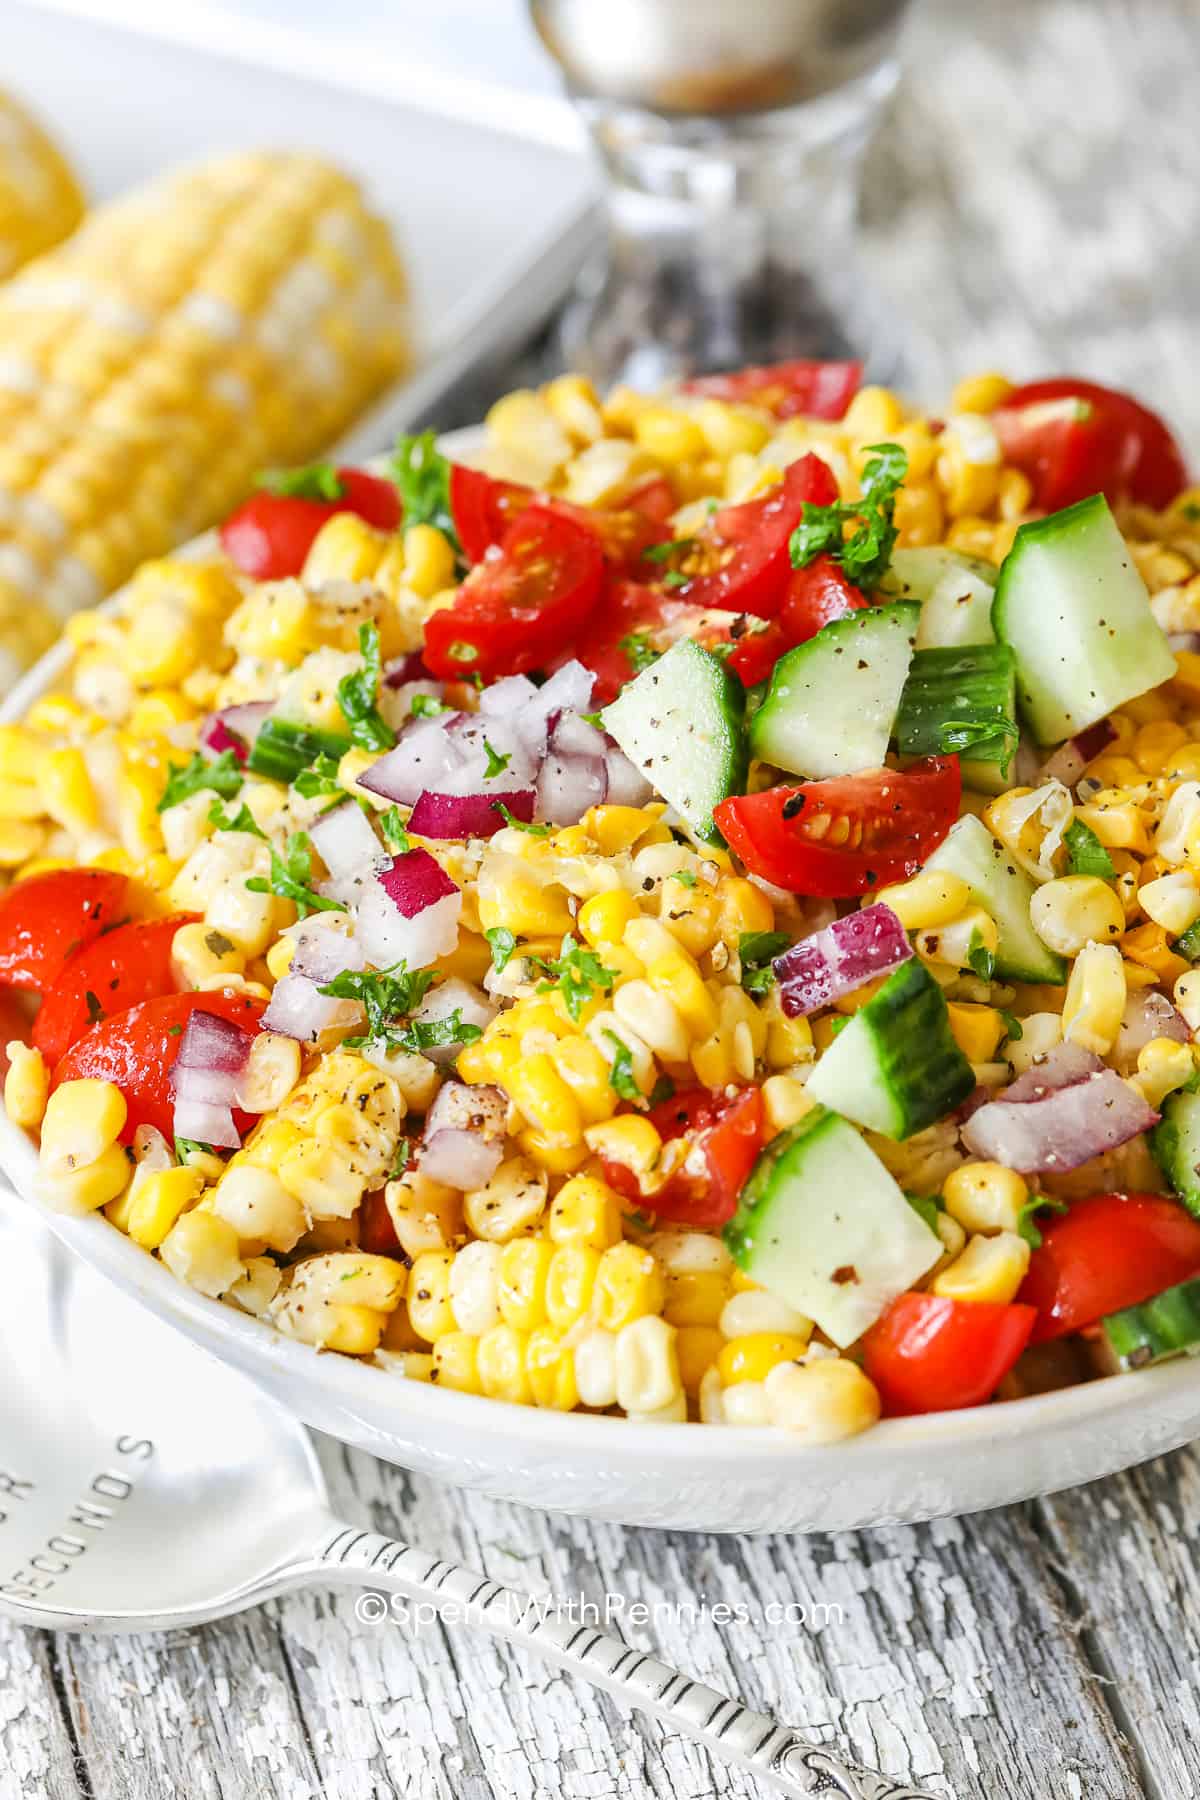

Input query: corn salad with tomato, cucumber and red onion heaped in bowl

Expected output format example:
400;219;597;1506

0;358;1200;1444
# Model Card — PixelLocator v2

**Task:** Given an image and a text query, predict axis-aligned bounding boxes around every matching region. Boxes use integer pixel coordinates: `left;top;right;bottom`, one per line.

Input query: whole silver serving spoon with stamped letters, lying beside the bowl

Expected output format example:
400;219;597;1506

0;1197;936;1800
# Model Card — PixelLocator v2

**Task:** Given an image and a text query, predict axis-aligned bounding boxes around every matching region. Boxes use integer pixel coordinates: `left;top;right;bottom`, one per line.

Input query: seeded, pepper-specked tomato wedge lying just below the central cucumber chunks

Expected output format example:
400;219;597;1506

712;756;963;900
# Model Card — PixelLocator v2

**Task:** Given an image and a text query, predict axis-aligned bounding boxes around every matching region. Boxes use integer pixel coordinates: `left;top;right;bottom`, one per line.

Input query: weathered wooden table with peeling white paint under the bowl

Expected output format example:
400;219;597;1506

0;0;1200;1800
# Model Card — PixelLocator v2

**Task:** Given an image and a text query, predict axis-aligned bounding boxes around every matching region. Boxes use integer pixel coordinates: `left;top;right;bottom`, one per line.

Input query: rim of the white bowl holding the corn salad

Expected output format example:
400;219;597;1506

0;427;1196;1474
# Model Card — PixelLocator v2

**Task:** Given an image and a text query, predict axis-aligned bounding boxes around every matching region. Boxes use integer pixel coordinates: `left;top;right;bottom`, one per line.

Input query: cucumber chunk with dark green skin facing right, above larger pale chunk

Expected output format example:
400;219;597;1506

806;956;975;1138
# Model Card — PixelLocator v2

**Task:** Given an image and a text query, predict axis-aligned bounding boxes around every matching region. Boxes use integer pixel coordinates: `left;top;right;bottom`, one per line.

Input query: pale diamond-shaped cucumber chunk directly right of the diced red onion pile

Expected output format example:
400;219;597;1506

601;637;747;844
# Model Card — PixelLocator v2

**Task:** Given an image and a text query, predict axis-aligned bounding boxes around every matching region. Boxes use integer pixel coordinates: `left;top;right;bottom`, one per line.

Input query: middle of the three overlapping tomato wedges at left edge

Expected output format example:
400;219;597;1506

32;913;196;1067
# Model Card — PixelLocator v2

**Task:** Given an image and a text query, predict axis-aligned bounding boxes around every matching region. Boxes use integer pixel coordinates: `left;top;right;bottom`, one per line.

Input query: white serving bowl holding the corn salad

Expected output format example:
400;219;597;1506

0;453;1200;1532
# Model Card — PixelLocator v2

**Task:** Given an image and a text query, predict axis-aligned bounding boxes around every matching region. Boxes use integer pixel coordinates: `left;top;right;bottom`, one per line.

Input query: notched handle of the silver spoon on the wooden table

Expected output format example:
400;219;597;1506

313;1525;945;1800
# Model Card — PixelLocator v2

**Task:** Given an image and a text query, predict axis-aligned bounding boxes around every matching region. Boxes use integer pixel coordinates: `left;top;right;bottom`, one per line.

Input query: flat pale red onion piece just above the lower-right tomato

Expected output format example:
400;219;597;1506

963;1069;1159;1175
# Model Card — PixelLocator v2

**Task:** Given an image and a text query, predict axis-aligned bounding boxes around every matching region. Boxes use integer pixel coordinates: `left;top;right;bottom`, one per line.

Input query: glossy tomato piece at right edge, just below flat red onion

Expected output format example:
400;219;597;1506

1016;1193;1200;1343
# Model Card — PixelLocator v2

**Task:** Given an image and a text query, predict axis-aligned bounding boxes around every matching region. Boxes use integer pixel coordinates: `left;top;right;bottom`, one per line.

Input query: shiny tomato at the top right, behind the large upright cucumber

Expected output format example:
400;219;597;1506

995;374;1187;513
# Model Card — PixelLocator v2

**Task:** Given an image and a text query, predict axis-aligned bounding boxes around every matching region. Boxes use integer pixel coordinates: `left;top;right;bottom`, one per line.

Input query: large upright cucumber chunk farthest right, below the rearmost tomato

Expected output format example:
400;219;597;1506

991;493;1175;743
